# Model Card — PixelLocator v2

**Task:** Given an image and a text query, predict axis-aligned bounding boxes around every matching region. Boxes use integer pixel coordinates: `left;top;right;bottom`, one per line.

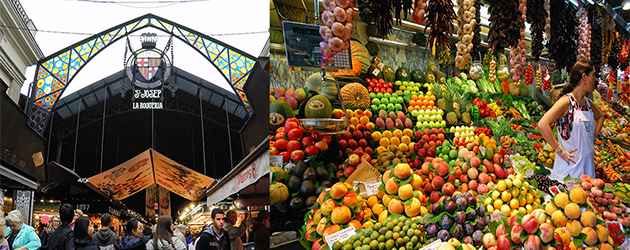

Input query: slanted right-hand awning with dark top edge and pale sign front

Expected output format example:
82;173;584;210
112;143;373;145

207;137;269;204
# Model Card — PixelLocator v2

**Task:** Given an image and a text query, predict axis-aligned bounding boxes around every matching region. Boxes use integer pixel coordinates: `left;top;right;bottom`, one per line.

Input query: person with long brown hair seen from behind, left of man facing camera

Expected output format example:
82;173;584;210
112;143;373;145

147;215;186;250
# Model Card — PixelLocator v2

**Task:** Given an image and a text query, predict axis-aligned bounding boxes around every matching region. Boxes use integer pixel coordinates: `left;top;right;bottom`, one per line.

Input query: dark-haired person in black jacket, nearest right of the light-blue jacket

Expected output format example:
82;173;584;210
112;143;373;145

48;203;75;250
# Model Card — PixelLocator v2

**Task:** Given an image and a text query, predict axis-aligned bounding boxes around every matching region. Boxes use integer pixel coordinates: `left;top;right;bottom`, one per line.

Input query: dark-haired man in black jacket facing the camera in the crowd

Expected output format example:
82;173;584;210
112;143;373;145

195;208;230;250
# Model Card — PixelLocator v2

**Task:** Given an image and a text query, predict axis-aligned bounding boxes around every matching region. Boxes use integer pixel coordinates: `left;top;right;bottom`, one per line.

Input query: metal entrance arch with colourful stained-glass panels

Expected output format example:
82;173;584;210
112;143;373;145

27;14;256;135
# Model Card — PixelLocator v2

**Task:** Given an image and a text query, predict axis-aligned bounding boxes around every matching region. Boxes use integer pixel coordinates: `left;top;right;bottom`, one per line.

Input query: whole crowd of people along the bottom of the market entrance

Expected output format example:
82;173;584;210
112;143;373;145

0;203;269;250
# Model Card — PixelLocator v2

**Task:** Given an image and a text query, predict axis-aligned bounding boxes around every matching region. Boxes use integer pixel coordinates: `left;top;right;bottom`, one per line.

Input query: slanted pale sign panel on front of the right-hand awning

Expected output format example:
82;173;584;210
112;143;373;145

207;150;269;204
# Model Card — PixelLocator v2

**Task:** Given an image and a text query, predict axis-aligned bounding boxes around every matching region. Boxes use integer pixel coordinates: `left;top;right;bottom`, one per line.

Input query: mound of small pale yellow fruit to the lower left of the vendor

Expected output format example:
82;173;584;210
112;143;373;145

484;174;541;216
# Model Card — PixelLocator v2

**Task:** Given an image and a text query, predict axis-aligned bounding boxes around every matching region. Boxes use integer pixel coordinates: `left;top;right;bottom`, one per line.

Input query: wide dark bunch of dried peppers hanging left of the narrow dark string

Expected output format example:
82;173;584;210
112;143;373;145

486;0;525;53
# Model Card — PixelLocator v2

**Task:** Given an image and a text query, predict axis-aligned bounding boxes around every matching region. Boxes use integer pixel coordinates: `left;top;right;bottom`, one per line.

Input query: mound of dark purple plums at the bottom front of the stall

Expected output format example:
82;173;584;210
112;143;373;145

425;192;488;245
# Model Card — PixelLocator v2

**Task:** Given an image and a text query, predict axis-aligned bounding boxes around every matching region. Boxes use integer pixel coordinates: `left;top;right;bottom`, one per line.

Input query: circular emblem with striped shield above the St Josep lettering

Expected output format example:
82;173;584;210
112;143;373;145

125;48;172;89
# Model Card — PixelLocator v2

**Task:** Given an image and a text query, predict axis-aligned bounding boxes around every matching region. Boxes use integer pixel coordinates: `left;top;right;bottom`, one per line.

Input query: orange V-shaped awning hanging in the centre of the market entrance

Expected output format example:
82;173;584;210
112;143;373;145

88;149;215;201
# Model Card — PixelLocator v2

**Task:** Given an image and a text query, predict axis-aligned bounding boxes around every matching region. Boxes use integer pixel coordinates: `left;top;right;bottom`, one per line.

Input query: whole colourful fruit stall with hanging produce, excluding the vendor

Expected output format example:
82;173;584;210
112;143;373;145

269;0;630;250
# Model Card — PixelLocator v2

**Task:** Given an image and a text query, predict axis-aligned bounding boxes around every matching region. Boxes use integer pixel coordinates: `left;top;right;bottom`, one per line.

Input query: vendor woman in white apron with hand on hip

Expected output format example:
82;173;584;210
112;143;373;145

538;60;604;182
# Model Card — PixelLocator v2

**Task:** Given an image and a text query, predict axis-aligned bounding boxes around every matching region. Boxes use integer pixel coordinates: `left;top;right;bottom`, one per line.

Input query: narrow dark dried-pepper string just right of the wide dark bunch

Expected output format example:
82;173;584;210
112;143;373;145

526;0;548;61
